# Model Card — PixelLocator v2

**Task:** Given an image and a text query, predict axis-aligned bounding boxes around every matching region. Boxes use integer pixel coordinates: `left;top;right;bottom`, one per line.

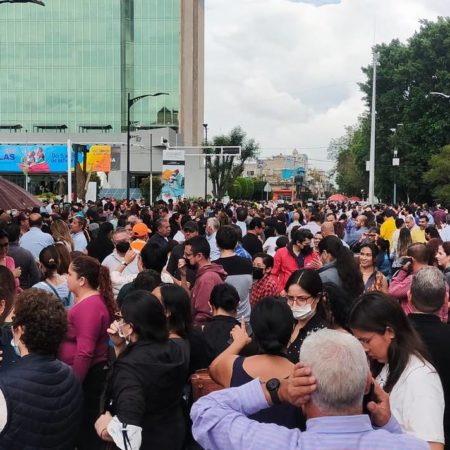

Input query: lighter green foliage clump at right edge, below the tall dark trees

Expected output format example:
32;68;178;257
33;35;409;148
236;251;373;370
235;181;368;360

424;145;450;203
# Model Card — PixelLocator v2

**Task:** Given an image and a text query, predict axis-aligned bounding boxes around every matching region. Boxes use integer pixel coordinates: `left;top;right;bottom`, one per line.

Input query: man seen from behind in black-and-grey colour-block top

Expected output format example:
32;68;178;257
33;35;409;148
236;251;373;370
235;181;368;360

215;225;253;322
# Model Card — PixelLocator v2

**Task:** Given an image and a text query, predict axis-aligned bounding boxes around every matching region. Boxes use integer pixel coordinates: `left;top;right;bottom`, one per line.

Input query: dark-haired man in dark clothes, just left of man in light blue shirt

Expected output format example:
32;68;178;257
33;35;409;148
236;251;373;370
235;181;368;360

6;224;41;289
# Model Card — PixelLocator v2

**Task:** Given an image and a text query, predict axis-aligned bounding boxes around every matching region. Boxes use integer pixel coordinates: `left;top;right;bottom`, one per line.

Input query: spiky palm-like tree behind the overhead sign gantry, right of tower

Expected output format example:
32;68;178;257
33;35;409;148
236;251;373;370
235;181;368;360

206;127;259;198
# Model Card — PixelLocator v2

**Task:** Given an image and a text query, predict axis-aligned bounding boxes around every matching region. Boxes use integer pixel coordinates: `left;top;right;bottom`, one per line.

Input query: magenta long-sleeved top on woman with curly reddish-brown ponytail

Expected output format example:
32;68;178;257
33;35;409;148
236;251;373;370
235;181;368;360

59;295;111;381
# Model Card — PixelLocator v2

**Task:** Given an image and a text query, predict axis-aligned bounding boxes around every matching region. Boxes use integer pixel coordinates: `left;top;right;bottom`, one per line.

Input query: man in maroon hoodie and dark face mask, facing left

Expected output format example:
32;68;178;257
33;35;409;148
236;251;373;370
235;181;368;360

178;236;227;325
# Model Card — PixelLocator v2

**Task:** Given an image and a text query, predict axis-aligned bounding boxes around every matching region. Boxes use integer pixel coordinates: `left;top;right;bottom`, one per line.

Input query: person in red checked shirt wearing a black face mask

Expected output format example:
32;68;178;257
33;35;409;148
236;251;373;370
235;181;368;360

250;253;278;306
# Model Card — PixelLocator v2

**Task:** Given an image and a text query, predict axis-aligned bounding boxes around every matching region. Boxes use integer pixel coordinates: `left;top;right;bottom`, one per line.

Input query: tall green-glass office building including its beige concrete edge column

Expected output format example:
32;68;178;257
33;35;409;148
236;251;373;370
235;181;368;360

0;0;204;196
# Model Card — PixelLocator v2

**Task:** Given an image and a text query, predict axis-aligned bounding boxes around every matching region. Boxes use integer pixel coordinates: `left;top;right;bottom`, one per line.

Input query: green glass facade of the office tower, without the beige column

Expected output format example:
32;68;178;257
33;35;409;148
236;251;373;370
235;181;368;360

0;0;183;133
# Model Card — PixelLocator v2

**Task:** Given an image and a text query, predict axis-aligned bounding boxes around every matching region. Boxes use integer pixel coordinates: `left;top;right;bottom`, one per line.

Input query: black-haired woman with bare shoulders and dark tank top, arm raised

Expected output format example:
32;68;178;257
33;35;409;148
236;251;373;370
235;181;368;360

209;297;301;428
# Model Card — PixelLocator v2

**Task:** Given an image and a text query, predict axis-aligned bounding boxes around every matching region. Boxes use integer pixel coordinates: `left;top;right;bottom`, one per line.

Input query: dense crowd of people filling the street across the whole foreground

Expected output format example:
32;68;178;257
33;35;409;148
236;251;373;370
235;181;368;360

0;199;450;450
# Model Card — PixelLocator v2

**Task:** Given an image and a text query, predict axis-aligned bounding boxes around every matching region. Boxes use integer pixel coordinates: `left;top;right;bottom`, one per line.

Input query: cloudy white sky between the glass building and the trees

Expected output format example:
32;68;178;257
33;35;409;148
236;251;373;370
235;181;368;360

205;0;450;170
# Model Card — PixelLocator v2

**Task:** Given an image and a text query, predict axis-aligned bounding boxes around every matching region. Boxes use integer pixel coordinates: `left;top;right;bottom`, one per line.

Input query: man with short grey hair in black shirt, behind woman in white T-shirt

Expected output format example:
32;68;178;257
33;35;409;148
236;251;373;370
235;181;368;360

408;267;450;444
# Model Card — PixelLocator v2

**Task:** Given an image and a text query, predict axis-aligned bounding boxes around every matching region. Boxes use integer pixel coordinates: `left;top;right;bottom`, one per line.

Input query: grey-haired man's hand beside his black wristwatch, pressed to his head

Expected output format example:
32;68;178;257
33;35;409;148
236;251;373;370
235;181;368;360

279;362;317;407
